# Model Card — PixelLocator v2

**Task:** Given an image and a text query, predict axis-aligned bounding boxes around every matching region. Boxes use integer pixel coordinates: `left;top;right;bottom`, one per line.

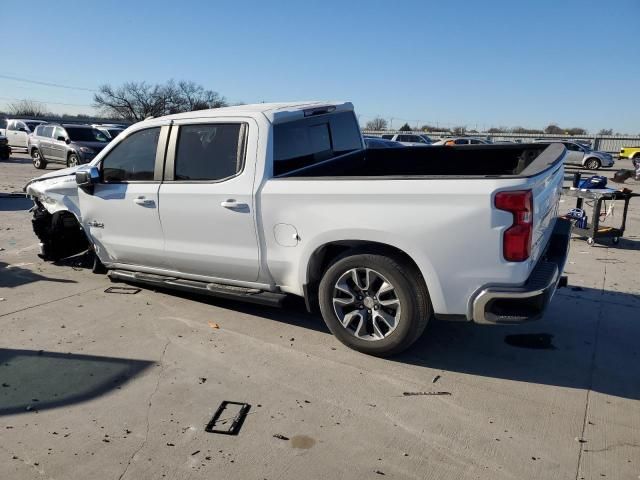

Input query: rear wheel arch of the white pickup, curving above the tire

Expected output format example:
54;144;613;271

303;239;442;311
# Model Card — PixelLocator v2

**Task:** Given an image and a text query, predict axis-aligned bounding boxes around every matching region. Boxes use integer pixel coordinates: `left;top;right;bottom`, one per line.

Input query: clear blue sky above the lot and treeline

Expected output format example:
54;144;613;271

0;0;640;134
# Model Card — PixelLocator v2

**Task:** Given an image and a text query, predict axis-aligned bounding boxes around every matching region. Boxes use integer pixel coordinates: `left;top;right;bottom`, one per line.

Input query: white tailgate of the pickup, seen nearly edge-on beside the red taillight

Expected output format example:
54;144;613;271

530;164;564;267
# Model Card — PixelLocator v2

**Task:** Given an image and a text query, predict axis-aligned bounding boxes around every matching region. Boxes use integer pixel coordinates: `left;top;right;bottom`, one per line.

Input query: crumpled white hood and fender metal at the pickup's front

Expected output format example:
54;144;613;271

23;165;84;219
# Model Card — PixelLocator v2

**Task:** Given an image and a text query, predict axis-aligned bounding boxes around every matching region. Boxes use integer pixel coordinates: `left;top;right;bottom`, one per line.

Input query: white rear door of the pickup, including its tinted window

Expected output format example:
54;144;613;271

160;122;259;282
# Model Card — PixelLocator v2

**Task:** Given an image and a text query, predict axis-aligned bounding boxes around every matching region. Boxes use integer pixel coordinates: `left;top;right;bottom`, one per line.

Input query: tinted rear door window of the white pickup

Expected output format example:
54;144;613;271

174;123;244;181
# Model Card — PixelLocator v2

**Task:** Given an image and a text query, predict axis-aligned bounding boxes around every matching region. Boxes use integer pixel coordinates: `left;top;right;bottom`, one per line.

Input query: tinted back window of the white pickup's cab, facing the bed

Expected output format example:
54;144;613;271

273;112;363;176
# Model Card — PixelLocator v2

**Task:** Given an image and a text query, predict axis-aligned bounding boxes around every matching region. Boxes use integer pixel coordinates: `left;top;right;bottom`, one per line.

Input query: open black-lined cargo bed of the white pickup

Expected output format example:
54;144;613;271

274;144;564;178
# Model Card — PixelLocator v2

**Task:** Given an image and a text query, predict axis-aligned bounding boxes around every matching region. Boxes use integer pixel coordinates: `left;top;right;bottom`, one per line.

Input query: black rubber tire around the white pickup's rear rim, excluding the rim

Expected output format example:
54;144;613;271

318;251;433;357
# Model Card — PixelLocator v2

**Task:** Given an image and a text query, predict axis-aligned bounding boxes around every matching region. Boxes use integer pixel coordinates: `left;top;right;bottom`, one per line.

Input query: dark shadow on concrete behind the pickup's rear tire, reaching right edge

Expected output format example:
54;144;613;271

391;287;640;400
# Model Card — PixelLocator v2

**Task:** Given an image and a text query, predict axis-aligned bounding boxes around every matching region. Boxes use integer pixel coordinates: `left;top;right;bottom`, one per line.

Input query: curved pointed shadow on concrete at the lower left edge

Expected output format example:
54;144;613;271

0;348;154;416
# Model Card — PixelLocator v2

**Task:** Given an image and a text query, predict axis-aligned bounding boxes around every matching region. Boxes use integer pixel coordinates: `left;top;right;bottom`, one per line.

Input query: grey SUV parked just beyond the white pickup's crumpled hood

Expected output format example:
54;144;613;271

28;123;111;169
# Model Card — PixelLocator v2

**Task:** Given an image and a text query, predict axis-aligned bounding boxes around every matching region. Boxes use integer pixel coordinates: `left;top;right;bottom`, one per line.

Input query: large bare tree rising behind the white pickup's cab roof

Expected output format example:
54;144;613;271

93;80;227;122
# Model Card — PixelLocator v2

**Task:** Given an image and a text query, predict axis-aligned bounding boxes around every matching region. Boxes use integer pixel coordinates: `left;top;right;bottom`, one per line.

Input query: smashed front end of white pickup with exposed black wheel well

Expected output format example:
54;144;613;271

24;167;90;260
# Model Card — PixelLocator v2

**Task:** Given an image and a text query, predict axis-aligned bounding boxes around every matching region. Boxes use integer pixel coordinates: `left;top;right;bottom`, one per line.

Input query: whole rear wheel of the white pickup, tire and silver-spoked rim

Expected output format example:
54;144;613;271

318;253;432;356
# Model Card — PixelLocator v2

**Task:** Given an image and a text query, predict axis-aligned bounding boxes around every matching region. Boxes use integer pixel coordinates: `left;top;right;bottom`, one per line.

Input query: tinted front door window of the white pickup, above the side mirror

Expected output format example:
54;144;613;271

102;127;160;183
